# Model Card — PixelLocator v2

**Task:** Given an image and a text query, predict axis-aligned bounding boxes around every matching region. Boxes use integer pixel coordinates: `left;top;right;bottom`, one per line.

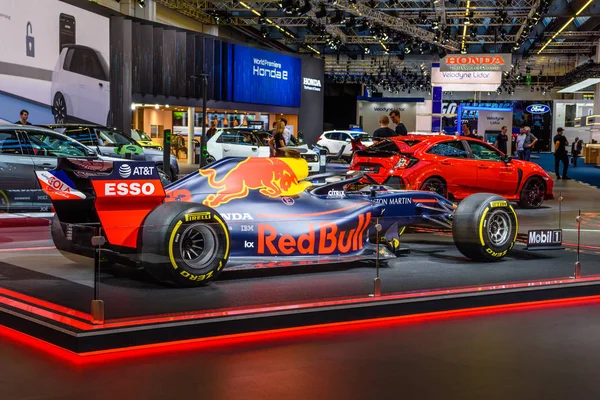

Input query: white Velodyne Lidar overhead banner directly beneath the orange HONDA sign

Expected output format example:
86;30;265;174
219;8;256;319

431;67;502;92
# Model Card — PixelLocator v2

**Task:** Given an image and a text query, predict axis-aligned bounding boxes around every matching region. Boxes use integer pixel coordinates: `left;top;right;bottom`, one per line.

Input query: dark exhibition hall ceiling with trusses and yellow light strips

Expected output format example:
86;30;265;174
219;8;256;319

156;0;600;83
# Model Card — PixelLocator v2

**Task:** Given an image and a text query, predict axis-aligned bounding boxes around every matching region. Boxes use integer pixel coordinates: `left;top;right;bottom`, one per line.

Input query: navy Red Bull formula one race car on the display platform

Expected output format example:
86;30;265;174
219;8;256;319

38;157;518;287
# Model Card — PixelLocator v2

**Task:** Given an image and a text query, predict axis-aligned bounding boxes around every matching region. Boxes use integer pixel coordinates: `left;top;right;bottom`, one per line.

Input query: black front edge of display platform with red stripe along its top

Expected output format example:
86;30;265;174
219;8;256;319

0;277;600;355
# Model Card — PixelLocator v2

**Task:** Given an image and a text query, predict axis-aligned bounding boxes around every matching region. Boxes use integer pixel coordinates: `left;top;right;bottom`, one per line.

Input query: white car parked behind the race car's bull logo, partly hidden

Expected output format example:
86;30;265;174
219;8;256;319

206;128;319;172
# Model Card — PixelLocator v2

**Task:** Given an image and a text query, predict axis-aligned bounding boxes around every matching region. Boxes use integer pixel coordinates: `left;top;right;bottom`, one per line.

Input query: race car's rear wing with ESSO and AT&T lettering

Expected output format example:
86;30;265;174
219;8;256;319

36;158;165;247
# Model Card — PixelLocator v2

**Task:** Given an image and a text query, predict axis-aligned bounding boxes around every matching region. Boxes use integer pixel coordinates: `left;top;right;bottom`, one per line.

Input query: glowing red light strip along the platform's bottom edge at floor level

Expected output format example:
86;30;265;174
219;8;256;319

0;296;600;364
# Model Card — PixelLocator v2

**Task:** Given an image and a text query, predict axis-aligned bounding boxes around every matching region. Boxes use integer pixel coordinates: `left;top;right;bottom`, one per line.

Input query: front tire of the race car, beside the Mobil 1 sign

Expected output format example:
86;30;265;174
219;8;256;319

452;193;519;261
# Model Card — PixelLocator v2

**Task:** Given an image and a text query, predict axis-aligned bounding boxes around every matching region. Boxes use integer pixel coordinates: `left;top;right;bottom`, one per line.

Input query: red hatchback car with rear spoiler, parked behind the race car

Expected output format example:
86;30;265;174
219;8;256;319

350;135;554;208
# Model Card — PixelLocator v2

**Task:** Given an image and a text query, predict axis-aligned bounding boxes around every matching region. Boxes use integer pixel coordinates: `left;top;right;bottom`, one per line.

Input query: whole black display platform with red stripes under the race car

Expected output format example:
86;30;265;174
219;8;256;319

0;230;600;355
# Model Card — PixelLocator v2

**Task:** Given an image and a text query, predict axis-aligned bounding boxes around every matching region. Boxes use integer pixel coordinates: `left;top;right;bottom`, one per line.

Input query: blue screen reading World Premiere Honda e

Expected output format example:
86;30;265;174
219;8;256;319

233;45;302;107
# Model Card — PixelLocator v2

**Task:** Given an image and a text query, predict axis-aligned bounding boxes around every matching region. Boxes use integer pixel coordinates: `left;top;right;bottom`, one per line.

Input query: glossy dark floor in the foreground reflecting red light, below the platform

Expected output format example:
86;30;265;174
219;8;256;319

0;296;600;400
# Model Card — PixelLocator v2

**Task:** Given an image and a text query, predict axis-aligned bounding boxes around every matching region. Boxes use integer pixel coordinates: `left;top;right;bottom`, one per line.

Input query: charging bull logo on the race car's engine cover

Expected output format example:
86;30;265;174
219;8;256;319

200;157;308;207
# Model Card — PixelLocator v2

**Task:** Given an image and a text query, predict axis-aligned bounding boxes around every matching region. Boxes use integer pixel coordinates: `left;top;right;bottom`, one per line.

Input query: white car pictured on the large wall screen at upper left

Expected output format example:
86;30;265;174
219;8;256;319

50;44;112;126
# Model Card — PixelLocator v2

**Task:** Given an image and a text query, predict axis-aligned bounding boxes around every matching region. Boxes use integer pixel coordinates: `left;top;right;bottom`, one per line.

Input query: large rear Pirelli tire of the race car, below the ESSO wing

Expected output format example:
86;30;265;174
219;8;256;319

138;202;230;287
